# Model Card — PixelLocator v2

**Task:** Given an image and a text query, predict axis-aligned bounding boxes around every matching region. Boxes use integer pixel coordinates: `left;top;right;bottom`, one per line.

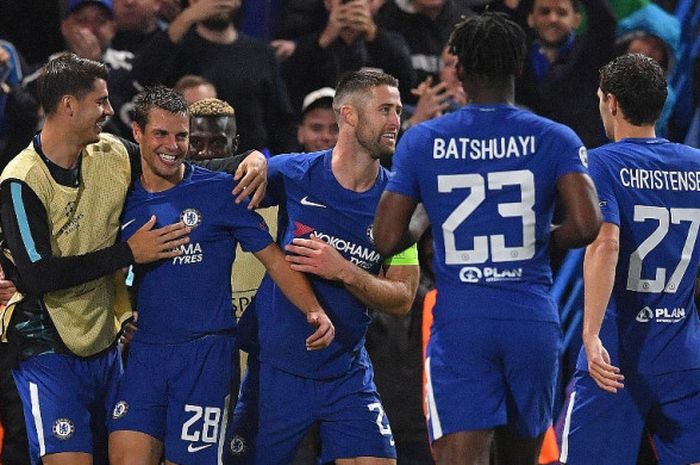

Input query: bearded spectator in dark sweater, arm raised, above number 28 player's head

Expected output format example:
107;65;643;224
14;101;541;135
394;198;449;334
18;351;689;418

133;0;296;153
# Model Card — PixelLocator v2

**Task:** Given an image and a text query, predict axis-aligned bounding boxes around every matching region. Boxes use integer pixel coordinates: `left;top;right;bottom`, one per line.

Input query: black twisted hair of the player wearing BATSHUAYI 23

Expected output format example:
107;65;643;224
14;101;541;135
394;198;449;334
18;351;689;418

448;12;526;82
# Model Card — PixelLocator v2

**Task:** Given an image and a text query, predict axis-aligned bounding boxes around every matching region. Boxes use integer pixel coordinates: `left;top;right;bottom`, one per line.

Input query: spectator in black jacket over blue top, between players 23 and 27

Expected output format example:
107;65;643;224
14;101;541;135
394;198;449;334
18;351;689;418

515;0;616;147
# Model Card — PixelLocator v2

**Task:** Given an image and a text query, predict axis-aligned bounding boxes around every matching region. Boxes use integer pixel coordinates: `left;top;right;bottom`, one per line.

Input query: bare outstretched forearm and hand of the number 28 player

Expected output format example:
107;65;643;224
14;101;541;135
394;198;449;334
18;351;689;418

254;243;335;350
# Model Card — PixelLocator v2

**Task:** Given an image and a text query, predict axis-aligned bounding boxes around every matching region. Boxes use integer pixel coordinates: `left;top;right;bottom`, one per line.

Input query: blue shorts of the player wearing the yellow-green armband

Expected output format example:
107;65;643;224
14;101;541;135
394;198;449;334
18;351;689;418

231;354;396;465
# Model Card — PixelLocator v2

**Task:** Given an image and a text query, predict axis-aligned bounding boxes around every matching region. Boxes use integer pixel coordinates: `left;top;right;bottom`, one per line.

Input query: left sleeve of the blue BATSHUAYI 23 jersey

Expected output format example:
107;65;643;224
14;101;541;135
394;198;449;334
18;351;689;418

386;126;426;201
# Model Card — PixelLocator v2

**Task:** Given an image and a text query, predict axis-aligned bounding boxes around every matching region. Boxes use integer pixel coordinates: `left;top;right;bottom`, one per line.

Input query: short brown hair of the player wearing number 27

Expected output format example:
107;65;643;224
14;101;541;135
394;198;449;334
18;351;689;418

600;53;668;126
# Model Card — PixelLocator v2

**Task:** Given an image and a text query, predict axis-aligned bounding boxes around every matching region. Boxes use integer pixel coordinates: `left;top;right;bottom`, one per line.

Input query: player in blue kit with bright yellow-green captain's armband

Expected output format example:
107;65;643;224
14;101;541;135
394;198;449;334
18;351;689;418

242;71;418;465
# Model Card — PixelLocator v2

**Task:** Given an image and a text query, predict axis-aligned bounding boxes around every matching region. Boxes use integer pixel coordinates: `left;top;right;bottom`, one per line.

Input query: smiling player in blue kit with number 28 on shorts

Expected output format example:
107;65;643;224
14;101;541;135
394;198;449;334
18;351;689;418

110;87;334;465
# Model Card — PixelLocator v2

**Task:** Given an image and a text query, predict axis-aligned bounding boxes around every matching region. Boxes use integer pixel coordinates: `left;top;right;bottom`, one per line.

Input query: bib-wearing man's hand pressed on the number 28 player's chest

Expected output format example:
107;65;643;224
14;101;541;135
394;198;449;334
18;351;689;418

126;216;190;263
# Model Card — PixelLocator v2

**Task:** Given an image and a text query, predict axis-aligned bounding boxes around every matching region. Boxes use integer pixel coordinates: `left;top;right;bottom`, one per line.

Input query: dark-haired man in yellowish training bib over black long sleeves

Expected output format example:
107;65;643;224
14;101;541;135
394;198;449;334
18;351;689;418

0;54;264;465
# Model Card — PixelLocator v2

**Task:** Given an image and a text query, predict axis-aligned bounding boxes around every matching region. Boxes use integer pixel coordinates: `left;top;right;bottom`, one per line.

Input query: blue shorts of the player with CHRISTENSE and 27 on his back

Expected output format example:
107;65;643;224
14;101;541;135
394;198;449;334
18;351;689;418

561;370;700;465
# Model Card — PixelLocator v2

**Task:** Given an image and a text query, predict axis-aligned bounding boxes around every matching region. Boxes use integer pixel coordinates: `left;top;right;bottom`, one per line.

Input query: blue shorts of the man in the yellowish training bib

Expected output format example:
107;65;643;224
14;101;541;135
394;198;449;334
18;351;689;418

12;348;122;465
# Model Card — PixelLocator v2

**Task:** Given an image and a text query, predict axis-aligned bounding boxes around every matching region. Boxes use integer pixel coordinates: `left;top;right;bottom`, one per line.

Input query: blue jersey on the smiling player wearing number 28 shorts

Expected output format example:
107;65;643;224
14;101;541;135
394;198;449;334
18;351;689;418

121;164;272;343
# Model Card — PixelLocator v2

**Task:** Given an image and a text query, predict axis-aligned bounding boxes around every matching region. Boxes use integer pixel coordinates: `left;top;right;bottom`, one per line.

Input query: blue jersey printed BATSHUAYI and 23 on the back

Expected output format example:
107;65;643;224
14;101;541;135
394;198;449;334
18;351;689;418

387;104;586;327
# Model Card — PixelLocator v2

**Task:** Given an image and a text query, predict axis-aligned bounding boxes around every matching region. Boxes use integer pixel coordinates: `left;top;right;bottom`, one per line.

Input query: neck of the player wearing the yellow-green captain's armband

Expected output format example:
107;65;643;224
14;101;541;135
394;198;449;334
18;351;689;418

331;143;379;192
